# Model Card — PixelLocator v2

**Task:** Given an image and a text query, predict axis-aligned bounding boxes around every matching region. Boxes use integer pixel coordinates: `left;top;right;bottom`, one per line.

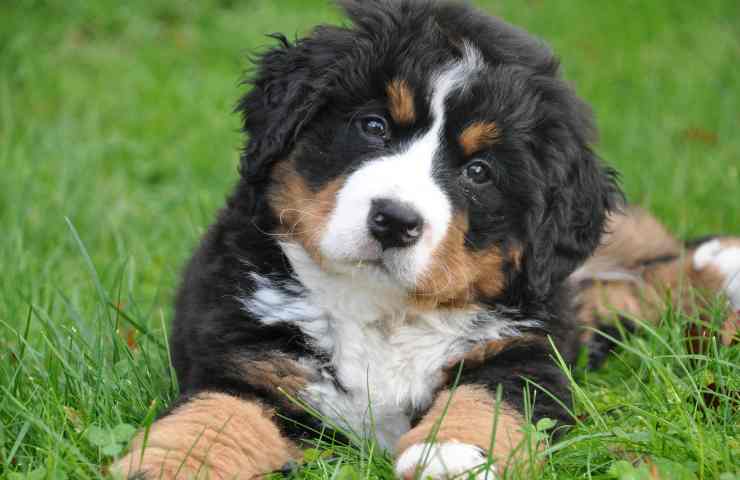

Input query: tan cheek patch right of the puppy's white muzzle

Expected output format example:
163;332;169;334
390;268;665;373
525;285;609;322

413;214;505;309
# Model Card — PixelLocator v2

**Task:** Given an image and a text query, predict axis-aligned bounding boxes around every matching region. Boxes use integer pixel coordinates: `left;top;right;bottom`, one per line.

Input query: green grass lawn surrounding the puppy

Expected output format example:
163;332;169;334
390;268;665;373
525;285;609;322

0;0;740;480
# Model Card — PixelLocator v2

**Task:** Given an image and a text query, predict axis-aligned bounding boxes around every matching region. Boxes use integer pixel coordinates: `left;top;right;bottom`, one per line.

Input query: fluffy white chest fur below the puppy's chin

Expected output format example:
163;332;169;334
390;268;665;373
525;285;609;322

237;244;534;448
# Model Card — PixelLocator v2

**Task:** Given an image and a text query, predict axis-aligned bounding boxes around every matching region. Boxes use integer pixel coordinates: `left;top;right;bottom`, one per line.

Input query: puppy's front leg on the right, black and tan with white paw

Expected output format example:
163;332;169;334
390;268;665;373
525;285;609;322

396;340;569;479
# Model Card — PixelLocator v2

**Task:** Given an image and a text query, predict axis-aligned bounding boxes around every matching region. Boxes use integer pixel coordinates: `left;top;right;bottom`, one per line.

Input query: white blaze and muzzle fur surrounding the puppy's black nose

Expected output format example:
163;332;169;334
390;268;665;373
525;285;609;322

320;45;483;288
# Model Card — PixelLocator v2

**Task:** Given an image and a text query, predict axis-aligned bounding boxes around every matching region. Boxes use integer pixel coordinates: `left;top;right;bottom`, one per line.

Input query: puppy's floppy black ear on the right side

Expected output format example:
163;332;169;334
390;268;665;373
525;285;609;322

524;83;623;298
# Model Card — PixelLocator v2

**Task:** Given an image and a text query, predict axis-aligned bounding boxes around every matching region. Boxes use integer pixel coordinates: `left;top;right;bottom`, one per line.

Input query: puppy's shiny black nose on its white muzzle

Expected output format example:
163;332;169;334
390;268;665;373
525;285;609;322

367;198;424;250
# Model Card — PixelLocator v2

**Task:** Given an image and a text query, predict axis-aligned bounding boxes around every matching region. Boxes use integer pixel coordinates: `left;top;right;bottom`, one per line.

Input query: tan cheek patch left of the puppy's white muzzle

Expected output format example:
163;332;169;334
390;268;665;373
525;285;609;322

269;160;345;262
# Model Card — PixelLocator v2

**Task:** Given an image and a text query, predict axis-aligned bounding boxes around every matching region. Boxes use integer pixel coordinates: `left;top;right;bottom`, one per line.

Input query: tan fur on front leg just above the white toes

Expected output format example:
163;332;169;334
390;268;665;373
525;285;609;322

396;385;527;466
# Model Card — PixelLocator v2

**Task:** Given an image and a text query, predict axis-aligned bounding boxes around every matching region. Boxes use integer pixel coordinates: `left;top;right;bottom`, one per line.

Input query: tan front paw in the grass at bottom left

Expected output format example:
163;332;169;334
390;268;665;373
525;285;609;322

112;393;300;479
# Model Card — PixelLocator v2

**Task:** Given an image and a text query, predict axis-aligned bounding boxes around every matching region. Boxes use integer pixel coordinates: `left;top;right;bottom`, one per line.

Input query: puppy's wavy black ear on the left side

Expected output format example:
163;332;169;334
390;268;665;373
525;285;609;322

235;34;324;183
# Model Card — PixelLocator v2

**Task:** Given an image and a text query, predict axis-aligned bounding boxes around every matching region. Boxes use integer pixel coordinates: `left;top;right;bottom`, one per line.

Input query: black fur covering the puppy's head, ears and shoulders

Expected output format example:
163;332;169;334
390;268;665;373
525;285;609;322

172;0;621;446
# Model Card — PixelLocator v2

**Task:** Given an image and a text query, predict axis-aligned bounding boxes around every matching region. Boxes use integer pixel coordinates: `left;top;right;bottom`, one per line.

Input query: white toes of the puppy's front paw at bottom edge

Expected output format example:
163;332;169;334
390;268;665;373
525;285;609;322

396;442;496;480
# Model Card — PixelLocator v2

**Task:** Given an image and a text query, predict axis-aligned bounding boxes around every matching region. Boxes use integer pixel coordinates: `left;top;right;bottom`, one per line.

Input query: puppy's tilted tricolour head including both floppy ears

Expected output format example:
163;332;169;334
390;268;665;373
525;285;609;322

238;0;619;305
